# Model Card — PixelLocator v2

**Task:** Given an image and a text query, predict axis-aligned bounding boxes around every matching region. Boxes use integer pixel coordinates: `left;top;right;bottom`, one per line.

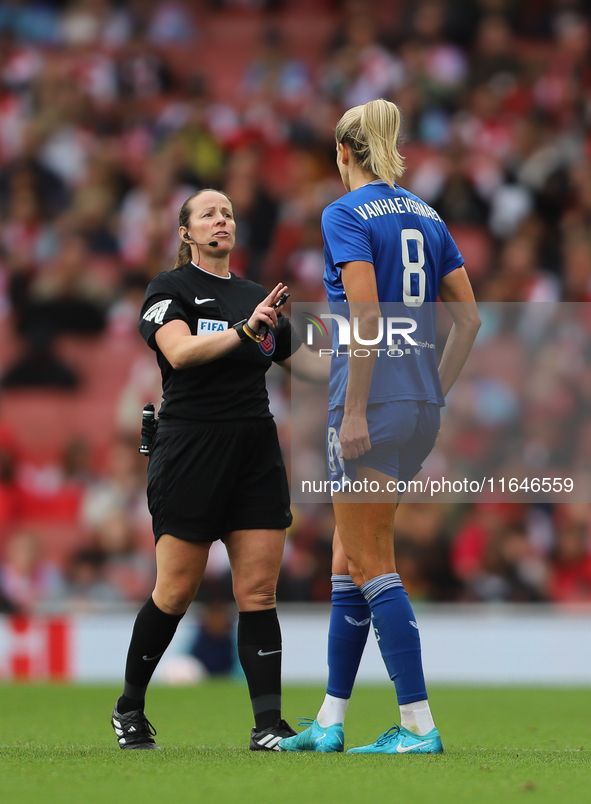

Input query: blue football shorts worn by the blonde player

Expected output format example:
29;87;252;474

326;399;441;490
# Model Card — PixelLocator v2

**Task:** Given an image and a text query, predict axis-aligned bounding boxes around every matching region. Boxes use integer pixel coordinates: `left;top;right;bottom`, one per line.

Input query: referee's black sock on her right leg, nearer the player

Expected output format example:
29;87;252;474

238;609;281;731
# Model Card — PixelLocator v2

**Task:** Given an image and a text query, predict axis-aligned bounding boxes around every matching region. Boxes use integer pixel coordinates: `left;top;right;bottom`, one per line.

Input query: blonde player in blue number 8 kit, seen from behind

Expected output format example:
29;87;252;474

280;100;480;754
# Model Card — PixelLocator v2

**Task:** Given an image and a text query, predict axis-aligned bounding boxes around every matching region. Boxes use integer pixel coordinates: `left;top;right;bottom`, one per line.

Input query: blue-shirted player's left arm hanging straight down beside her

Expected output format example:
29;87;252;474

339;260;381;460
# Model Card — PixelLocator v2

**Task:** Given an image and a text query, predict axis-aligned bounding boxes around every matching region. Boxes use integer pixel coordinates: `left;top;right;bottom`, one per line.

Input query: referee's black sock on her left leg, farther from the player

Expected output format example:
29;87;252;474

117;597;184;715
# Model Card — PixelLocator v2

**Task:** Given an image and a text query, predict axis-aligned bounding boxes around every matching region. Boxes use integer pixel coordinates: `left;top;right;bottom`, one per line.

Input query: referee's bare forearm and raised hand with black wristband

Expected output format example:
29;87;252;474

154;283;285;370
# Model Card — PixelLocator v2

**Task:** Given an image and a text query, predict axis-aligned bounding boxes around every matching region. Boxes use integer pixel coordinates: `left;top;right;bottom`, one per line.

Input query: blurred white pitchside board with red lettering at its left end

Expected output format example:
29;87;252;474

0;605;591;686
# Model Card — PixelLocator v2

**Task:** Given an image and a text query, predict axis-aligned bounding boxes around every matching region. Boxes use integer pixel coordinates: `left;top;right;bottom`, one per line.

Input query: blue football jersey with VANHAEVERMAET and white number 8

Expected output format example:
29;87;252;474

322;180;464;408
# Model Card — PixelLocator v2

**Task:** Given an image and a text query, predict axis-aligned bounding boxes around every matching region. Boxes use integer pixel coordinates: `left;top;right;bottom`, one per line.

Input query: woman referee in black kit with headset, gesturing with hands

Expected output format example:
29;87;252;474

112;190;329;751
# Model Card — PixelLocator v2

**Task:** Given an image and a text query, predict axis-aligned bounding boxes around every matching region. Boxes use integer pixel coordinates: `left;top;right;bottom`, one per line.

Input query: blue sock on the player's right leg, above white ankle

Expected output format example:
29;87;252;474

361;572;427;704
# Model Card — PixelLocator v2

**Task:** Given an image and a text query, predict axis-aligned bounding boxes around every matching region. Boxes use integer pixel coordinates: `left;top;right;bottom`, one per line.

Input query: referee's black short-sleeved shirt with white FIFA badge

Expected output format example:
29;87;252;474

139;263;301;422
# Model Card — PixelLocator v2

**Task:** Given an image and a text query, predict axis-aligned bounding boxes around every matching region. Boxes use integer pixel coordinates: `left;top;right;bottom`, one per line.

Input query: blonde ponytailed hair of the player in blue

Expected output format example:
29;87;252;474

335;98;404;187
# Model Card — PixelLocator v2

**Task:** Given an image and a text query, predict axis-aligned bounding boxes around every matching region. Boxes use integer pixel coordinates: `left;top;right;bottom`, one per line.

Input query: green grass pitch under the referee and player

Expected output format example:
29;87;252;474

0;682;591;804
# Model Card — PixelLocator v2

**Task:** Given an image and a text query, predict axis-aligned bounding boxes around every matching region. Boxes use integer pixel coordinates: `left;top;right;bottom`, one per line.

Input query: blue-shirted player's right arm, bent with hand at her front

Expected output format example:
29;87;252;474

439;265;482;396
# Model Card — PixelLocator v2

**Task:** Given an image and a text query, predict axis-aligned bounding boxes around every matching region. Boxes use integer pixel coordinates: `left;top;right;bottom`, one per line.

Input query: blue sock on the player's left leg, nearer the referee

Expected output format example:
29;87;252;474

326;575;371;698
